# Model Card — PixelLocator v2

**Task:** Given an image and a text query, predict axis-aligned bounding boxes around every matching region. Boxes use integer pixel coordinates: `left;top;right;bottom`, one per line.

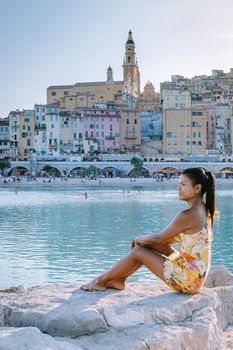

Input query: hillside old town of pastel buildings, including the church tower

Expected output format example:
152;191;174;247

0;30;233;161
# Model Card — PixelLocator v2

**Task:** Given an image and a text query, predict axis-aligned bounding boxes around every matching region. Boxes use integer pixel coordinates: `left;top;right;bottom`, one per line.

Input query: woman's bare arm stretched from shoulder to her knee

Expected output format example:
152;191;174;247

132;210;194;248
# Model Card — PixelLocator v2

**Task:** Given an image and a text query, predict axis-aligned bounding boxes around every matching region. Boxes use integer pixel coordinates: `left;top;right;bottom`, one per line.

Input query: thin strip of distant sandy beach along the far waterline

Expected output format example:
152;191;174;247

0;178;233;190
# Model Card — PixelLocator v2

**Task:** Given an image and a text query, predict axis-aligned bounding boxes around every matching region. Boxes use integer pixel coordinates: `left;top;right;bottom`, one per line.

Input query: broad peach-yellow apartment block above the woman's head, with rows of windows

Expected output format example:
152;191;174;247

163;108;207;155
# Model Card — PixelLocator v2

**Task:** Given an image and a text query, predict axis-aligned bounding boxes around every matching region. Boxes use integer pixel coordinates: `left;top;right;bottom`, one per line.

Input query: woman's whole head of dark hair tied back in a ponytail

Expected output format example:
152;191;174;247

182;168;216;226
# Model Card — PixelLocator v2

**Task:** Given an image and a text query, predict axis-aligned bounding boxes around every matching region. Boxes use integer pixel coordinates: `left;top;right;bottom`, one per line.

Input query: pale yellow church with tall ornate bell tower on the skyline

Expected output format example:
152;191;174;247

47;31;140;110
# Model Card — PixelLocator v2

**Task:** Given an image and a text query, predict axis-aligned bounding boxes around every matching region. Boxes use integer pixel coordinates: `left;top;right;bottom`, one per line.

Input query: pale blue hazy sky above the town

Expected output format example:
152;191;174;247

0;0;233;118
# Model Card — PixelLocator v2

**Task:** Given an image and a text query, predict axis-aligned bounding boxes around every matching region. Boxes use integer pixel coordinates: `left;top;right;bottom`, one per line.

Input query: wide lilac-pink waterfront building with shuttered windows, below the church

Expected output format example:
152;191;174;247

81;107;121;152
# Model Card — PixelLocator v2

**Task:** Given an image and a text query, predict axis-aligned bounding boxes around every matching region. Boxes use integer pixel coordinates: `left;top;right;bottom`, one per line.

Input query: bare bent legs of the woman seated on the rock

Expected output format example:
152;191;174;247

81;246;165;291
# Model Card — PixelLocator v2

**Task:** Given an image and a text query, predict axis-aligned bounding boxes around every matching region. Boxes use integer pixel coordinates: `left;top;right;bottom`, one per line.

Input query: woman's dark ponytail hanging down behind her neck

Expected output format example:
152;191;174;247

205;171;216;226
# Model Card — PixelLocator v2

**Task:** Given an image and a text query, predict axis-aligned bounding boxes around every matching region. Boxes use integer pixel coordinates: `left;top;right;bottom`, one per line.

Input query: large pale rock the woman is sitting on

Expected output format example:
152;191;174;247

0;267;233;350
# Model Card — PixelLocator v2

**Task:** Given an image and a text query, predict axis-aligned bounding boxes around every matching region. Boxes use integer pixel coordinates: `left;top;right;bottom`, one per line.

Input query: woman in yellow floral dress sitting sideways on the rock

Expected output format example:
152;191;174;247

80;168;215;294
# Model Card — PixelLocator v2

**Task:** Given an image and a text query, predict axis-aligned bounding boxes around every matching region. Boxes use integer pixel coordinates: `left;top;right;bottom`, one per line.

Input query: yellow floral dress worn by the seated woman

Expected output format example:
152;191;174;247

163;222;213;294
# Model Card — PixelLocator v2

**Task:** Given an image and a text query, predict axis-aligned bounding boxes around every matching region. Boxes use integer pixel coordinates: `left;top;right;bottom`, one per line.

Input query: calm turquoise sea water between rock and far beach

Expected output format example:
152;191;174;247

0;185;233;289
